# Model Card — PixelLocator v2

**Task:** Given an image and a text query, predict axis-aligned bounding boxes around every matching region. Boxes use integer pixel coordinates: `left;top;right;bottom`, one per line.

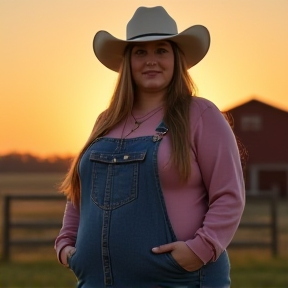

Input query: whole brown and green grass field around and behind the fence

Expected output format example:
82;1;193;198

0;174;288;288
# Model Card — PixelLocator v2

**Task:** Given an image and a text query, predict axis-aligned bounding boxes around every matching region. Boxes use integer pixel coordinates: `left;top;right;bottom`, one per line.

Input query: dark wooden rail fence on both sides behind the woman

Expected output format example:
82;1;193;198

2;193;278;261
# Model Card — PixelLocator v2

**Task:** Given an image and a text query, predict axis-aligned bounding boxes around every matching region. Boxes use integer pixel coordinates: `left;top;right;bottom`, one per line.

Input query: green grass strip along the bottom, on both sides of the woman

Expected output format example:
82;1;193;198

0;251;288;288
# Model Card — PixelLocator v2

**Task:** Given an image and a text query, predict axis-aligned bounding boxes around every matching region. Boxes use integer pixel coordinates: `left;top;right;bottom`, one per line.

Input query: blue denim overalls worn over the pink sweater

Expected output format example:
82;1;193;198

69;122;229;288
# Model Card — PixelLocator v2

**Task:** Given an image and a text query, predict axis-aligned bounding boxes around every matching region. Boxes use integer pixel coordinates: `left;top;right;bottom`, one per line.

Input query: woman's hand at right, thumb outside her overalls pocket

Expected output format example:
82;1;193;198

152;241;204;272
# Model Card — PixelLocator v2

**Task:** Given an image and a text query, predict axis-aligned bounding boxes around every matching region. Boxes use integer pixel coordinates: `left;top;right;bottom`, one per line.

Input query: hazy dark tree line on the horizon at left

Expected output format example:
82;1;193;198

0;153;72;173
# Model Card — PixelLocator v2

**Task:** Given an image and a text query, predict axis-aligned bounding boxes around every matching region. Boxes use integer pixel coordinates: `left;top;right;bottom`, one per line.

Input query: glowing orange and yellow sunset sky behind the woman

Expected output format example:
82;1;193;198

0;0;288;157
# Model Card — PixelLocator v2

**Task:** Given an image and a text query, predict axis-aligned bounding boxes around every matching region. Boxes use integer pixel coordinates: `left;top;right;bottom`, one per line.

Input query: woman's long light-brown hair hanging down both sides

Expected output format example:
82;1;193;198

59;42;196;207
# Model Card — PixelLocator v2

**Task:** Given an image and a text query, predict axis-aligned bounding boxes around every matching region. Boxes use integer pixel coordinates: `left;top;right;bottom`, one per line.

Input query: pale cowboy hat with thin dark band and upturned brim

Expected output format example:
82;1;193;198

93;6;210;72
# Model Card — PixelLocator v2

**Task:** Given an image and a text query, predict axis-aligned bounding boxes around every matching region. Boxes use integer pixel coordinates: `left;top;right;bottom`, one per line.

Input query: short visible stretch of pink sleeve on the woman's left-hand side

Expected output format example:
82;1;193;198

54;201;80;262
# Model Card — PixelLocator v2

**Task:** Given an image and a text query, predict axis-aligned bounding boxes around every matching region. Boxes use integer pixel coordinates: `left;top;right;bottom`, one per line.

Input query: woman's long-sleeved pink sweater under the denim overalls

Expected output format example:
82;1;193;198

55;97;245;263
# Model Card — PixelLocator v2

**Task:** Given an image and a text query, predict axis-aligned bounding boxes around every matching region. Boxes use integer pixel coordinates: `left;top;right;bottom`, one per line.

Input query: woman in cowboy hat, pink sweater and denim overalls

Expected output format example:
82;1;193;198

55;7;244;288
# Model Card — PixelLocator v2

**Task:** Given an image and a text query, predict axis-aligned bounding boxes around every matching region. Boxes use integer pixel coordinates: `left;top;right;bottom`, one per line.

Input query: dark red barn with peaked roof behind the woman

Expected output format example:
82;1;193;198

228;100;288;197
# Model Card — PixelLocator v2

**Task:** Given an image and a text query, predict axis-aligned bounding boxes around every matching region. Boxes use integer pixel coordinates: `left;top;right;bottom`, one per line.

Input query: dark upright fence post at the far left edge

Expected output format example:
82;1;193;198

2;195;11;261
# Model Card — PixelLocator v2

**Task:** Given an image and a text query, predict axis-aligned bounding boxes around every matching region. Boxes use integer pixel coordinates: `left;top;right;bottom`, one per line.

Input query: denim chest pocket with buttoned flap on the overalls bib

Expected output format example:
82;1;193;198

90;151;146;210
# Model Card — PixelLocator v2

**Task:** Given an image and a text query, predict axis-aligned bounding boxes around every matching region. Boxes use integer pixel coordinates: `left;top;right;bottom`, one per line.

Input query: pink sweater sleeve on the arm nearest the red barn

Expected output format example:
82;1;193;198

186;105;245;263
